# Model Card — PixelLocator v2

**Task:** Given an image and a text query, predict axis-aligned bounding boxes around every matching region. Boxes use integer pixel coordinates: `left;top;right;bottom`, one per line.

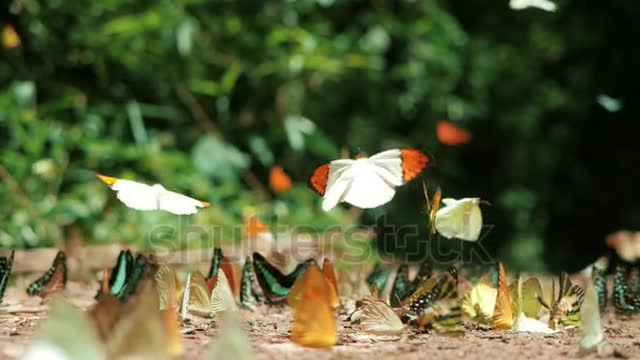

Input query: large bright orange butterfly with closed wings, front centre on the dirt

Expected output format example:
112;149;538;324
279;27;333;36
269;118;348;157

291;264;338;348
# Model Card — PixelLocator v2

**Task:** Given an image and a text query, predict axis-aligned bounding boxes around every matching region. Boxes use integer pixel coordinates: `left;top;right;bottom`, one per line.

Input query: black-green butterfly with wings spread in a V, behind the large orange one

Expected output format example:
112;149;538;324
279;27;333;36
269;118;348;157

253;252;315;304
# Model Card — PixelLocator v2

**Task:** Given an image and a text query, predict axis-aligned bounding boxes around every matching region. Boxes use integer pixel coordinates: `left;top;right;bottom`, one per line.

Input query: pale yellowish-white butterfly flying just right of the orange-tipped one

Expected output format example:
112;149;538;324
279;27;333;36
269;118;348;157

435;198;482;241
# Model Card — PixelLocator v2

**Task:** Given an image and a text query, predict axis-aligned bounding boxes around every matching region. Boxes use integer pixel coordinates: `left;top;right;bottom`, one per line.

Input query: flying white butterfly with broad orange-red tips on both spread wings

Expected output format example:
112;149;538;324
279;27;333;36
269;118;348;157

309;149;430;211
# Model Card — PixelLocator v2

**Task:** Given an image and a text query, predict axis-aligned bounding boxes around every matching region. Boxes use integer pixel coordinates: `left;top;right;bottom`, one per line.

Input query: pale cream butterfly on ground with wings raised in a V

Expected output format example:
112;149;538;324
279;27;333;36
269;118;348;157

187;271;237;317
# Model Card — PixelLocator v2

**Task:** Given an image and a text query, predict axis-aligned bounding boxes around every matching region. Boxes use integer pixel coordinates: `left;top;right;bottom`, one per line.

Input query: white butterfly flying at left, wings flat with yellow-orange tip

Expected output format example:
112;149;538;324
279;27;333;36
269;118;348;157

96;174;211;215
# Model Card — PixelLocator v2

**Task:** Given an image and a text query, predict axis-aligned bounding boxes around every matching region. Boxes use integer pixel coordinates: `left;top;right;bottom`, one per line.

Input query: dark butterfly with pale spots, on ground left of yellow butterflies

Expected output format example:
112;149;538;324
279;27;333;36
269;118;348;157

407;272;464;333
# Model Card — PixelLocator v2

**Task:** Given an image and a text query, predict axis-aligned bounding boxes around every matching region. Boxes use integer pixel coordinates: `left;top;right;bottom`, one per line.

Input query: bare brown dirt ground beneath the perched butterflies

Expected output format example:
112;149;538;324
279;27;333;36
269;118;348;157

0;282;640;360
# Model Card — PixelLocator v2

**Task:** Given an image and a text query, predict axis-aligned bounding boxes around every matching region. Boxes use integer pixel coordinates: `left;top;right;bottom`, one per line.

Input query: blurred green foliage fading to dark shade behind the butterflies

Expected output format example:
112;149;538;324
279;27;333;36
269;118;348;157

0;0;640;270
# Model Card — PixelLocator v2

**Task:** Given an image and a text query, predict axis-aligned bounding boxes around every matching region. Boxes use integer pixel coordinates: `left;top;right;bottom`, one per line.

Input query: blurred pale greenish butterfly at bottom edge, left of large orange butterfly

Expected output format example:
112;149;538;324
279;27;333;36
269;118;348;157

208;313;254;360
